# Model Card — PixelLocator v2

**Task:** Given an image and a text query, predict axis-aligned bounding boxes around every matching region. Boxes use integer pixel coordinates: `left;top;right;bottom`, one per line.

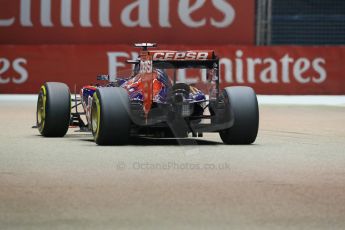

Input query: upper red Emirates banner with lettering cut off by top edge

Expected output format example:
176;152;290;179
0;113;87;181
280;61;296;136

0;0;255;45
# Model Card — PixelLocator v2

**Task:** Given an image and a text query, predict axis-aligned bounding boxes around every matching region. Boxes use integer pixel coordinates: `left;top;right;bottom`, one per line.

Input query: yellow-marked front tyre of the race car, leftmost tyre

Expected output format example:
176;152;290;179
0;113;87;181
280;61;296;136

36;82;71;137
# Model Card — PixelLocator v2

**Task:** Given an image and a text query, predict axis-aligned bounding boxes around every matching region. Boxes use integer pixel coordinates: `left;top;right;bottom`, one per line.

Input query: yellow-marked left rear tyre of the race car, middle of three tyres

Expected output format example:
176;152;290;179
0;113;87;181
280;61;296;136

91;87;131;145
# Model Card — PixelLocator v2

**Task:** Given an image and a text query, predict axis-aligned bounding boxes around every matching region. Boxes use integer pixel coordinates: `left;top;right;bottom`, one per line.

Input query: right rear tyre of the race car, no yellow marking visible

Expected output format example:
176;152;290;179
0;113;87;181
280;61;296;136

219;86;259;144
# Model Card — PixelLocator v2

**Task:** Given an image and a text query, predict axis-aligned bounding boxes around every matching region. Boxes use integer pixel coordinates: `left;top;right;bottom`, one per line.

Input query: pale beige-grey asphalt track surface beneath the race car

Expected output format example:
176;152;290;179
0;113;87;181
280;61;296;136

0;101;345;230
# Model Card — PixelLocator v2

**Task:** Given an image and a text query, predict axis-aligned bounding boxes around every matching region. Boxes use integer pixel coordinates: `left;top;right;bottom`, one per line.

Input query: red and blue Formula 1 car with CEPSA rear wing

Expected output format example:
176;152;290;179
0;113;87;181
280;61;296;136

36;43;259;145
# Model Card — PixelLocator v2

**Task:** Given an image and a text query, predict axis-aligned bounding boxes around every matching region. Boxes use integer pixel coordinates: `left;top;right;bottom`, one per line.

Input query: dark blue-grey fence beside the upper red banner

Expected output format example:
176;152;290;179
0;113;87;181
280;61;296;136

257;0;345;45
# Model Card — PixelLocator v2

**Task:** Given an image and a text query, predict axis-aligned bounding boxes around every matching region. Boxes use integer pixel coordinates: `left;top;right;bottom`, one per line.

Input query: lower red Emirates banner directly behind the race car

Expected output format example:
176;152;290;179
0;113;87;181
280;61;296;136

0;45;345;95
